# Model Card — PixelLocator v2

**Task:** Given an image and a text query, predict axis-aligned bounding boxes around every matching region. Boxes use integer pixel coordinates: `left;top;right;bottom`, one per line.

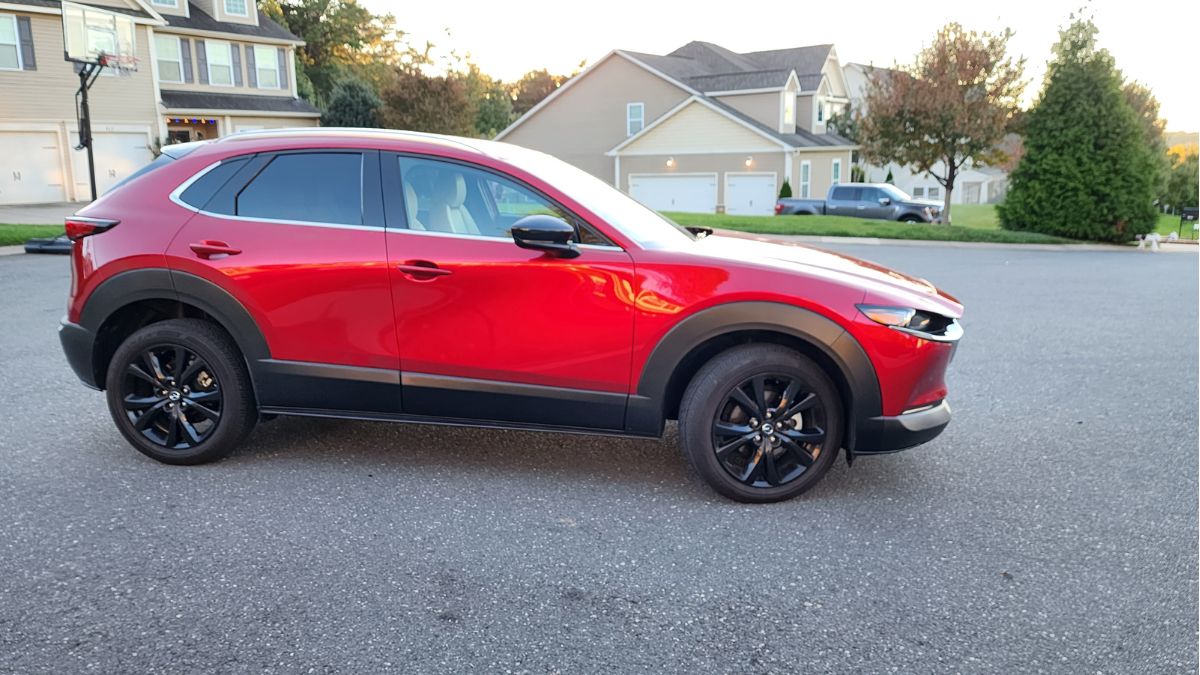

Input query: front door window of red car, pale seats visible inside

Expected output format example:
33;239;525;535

400;157;608;245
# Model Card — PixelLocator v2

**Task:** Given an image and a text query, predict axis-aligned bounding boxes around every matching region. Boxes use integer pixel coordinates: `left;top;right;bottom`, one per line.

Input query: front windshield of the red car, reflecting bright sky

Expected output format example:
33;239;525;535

480;142;696;249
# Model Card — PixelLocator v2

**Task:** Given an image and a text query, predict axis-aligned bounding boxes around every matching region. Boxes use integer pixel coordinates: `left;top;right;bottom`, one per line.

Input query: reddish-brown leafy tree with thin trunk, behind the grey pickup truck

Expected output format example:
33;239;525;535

858;23;1025;222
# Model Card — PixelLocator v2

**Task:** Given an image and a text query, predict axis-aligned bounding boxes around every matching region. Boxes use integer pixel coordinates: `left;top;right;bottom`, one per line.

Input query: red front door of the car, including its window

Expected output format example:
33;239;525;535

382;154;634;429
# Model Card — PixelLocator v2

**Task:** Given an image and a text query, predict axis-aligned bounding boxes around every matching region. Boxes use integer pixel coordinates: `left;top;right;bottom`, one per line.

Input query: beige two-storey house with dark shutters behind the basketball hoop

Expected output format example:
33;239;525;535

0;0;320;204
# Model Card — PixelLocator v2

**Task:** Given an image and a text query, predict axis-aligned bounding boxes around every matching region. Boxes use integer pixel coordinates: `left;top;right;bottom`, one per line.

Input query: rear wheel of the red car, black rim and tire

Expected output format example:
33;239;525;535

104;318;258;465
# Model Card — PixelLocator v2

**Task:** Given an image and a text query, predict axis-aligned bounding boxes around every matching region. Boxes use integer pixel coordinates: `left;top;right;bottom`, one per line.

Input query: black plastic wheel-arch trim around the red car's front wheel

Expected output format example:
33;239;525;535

625;301;883;450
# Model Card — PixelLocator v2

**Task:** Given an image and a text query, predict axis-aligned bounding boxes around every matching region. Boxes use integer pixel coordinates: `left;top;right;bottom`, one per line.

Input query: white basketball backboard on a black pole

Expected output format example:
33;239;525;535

62;0;138;71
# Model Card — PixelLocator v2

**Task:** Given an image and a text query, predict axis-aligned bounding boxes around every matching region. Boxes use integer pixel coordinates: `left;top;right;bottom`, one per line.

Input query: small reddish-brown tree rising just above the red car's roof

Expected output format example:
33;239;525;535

380;66;475;136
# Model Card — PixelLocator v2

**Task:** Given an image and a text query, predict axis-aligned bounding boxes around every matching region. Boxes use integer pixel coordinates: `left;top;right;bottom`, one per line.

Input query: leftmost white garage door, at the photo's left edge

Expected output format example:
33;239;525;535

0;131;66;204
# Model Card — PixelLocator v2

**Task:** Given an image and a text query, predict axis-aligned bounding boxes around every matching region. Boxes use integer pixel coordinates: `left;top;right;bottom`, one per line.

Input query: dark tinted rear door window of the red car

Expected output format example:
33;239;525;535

236;153;362;225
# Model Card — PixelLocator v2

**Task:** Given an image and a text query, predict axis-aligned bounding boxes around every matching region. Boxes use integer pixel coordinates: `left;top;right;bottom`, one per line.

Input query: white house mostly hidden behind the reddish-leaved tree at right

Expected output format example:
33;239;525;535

842;64;1019;204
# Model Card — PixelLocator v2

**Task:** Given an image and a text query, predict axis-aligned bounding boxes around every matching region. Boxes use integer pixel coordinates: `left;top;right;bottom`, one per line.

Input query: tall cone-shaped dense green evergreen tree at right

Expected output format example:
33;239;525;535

998;17;1157;241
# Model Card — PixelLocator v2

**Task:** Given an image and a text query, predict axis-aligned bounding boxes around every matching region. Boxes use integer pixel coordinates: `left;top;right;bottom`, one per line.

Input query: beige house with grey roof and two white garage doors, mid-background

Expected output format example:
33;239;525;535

497;42;854;214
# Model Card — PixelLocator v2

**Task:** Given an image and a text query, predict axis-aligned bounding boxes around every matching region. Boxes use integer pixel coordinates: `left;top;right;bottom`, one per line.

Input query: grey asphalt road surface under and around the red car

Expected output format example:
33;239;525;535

0;246;1198;674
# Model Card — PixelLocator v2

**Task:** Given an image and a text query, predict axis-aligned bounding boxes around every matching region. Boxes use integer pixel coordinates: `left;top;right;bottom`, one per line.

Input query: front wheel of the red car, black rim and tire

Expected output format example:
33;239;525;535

679;345;844;502
